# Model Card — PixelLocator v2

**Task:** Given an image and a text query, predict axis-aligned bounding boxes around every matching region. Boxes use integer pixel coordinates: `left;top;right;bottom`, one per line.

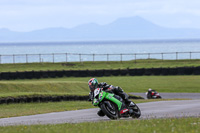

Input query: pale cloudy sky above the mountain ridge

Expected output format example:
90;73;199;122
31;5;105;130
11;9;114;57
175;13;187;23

0;0;200;32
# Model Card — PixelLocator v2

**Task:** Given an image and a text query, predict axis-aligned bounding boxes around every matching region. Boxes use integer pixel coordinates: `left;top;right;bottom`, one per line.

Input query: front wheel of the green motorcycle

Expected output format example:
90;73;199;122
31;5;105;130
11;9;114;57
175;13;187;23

101;101;118;120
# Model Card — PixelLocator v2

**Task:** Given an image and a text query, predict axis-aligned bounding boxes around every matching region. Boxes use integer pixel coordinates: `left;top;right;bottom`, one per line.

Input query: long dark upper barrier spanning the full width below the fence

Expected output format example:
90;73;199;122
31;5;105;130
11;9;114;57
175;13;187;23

0;67;200;80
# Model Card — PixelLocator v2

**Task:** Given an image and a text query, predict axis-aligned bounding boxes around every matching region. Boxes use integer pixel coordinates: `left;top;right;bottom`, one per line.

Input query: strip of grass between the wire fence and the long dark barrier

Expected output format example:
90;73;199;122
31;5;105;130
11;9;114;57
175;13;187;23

0;59;200;72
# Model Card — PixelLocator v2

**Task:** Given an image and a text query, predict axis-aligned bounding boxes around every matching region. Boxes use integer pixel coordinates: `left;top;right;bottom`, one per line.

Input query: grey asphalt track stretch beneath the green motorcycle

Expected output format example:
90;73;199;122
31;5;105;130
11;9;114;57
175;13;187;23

0;99;200;126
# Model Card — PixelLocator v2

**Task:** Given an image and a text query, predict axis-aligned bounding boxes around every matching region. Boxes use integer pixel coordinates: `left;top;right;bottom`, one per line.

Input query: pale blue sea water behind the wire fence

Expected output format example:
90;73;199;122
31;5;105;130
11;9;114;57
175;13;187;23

0;40;200;63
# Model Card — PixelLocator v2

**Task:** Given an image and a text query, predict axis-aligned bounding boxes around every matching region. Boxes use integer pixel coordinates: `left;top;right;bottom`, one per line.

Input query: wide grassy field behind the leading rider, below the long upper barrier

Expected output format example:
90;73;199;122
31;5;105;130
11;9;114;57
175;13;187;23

0;75;200;97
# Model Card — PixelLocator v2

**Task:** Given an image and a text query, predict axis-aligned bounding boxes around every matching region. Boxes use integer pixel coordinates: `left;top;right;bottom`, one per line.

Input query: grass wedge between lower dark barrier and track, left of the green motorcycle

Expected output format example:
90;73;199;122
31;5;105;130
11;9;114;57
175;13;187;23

0;101;94;118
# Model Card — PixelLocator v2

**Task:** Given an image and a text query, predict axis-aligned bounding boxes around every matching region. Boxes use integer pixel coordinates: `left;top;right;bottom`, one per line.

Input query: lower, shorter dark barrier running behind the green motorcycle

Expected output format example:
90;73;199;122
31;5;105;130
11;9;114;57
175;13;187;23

0;96;143;104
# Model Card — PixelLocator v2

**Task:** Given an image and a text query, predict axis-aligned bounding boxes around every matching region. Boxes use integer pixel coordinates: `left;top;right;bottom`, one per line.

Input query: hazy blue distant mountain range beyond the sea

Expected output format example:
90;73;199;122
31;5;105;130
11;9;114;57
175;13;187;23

0;16;200;42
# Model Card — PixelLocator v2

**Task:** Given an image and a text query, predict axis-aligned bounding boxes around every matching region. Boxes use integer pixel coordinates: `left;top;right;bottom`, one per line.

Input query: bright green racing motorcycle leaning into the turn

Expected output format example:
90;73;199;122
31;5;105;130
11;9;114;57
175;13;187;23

93;88;141;120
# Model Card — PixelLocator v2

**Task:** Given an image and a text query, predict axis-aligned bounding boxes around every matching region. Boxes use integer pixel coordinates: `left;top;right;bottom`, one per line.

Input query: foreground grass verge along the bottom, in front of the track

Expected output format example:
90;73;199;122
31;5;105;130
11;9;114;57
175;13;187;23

0;118;200;133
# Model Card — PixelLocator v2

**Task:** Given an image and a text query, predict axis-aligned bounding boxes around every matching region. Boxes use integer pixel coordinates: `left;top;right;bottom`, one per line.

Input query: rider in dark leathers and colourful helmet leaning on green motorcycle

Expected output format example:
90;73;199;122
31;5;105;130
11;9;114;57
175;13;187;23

88;78;134;116
